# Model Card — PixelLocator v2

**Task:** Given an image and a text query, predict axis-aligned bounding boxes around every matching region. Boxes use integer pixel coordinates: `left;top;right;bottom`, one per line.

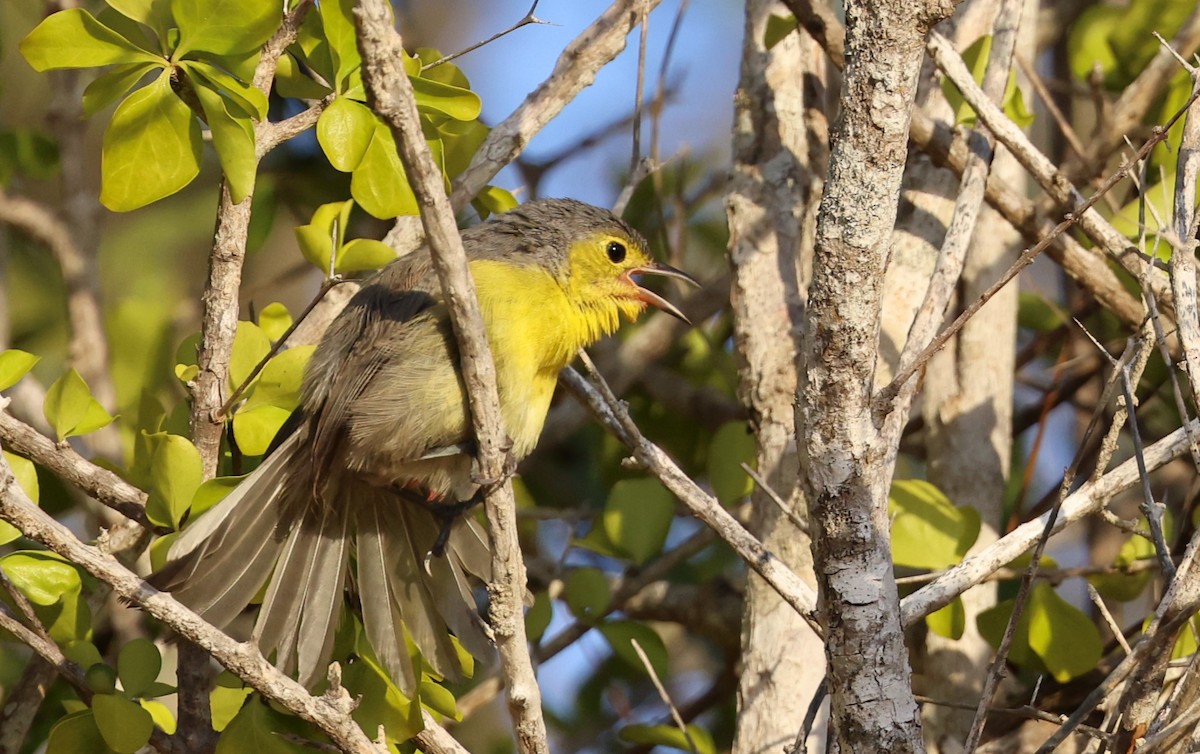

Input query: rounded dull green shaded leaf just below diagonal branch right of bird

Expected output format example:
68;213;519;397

601;479;674;566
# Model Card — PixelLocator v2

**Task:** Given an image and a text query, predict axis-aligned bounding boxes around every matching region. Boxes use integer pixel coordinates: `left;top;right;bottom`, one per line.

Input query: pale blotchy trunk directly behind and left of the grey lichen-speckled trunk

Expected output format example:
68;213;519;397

727;0;824;754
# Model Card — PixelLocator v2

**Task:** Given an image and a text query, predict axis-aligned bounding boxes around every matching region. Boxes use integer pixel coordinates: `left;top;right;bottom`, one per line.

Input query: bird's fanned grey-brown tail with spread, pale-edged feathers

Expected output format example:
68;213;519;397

150;432;492;695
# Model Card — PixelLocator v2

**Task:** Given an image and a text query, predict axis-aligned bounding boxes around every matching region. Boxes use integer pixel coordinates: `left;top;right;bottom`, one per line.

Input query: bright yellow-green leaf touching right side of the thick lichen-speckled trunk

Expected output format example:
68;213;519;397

888;479;979;570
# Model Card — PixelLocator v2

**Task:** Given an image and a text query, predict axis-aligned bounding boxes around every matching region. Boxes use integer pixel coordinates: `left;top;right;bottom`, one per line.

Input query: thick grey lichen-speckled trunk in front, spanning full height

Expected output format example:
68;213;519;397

797;0;954;752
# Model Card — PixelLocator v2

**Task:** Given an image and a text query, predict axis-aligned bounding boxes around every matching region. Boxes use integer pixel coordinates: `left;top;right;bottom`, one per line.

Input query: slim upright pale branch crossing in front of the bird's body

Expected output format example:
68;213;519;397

354;0;550;754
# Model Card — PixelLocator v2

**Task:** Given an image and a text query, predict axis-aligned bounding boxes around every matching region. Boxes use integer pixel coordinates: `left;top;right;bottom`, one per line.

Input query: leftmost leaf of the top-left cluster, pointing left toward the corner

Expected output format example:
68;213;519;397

19;8;163;71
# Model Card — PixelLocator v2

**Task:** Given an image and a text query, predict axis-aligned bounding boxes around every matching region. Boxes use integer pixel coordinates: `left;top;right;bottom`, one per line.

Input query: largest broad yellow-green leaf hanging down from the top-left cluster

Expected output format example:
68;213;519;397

100;72;200;213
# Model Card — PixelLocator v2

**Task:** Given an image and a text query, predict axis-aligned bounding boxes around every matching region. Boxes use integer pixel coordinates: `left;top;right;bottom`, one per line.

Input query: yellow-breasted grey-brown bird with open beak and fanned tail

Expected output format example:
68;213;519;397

149;199;697;696
